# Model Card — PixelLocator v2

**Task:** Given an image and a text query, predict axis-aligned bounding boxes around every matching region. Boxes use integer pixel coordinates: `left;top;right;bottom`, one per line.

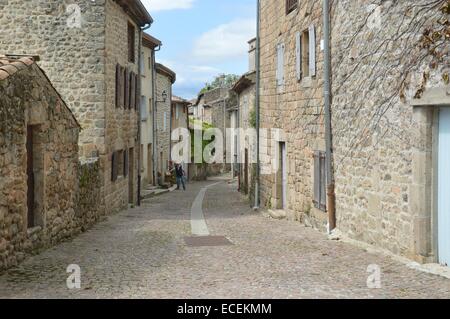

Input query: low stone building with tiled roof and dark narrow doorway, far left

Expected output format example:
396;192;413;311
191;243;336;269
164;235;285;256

0;55;80;271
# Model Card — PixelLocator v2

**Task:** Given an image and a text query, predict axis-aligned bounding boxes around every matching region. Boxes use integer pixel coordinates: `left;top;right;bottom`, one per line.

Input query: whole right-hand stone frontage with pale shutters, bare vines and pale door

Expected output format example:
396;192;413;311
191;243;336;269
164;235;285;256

260;0;450;265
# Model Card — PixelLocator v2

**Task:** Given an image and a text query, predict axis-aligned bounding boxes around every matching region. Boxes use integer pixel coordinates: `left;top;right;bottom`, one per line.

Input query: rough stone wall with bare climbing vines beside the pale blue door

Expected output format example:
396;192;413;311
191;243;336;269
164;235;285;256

332;0;450;261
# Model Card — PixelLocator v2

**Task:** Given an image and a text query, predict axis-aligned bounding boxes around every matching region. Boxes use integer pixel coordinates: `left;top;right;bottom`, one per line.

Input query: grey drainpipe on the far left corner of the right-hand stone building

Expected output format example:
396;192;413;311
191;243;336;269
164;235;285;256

254;0;261;210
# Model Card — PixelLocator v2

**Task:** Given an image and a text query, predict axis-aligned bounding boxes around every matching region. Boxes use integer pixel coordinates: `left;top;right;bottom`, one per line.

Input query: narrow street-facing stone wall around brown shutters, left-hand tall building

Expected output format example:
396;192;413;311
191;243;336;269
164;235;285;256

103;0;140;212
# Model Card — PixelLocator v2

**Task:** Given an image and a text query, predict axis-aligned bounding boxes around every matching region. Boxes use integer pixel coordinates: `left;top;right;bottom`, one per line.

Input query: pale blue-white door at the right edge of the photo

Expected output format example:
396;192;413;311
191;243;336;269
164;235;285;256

438;107;450;266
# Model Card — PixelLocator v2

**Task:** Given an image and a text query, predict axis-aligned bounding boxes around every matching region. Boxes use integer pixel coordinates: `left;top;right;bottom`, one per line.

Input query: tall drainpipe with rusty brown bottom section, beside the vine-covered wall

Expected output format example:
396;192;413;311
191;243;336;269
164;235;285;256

323;0;336;232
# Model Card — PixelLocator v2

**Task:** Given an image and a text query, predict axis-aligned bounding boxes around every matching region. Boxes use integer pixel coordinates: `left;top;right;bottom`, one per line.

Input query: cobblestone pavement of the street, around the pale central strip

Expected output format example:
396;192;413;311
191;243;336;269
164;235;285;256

0;181;450;298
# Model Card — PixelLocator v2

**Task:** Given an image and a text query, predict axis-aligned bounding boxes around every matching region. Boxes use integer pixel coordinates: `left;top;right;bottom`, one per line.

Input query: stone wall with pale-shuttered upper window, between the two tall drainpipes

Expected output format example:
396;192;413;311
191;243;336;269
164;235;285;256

259;0;327;226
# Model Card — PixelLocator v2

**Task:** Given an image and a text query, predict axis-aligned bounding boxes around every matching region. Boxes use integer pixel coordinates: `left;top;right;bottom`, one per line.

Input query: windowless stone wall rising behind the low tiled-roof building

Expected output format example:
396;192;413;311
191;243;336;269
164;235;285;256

0;0;106;157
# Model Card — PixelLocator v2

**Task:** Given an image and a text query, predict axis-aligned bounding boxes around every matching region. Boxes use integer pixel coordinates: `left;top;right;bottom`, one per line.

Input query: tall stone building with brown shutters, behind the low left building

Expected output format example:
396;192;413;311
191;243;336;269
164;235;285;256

0;0;153;213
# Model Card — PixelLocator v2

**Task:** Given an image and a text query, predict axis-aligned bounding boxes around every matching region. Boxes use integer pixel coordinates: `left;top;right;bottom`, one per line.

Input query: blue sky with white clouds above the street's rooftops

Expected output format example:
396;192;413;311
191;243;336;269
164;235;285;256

141;0;256;99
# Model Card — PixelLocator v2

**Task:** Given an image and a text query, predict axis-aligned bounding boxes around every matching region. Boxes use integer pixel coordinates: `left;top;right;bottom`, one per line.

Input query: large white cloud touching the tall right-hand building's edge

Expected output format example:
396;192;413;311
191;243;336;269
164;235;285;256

192;19;256;62
